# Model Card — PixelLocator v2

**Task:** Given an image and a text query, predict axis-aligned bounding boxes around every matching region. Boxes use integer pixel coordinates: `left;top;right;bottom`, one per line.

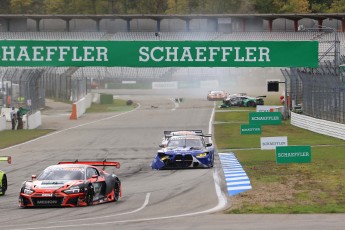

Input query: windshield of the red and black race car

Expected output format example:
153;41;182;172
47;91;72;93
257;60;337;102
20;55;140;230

37;168;85;180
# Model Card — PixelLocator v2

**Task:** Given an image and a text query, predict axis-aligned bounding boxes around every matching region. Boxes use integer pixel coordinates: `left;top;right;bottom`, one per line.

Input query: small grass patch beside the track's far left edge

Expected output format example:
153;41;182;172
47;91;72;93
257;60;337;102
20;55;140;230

86;99;137;113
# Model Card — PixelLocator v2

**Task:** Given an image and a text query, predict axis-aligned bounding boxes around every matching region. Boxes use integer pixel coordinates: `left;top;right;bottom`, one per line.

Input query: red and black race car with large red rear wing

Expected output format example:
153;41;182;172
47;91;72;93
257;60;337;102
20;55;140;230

19;161;122;207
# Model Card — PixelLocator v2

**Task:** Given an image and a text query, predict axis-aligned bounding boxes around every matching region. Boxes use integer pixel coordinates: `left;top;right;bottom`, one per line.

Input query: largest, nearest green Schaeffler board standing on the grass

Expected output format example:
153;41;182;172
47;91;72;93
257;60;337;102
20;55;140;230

276;146;311;164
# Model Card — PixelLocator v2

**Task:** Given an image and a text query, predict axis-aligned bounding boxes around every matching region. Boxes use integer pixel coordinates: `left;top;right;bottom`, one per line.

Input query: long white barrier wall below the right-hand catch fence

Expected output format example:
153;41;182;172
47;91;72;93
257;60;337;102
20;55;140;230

291;112;345;140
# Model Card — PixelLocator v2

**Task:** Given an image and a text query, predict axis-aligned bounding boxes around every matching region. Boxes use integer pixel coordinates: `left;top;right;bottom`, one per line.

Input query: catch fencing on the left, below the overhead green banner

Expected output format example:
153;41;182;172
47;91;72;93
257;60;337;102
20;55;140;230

0;67;91;113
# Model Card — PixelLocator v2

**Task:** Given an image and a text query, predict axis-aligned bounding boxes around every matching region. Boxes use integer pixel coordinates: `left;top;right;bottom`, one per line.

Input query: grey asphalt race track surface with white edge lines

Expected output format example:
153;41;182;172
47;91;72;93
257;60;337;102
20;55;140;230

0;88;345;230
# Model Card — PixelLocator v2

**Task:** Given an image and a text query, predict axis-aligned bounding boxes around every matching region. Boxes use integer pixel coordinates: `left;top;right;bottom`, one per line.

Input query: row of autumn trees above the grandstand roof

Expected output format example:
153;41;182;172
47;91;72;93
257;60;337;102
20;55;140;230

0;0;345;14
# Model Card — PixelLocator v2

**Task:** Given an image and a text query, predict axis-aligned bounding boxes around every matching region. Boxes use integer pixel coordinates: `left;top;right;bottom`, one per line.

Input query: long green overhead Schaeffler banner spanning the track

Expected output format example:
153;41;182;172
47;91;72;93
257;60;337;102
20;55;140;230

0;40;318;68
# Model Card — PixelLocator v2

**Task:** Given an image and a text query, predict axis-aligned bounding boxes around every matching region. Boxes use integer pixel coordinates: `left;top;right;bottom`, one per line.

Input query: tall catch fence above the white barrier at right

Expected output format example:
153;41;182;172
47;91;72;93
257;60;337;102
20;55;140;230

281;29;345;123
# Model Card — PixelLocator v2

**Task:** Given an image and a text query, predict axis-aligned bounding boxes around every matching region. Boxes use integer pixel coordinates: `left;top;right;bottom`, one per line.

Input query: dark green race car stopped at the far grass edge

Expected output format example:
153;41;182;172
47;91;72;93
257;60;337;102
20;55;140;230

221;93;266;107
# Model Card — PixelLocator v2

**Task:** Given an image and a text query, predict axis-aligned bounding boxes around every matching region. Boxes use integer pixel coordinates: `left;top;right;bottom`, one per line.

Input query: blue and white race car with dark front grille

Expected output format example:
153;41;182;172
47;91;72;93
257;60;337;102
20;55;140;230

151;135;214;169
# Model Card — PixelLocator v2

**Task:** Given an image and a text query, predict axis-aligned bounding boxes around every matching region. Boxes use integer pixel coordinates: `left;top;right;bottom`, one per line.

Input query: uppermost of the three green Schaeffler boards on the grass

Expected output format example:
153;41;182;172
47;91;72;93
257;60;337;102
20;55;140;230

249;112;282;125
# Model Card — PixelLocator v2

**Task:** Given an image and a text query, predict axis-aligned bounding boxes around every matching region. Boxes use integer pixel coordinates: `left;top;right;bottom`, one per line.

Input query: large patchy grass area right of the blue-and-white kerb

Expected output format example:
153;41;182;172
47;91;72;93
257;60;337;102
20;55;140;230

214;108;345;213
